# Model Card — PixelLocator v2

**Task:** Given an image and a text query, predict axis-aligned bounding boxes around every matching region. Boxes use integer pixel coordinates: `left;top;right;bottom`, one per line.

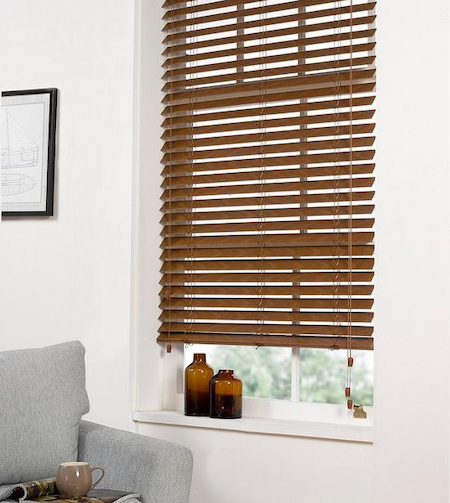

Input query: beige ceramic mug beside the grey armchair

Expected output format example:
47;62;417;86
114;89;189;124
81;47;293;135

56;461;105;498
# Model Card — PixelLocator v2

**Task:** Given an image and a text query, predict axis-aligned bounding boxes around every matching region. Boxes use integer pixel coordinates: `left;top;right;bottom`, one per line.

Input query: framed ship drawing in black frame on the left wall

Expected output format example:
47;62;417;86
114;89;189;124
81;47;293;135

0;89;58;216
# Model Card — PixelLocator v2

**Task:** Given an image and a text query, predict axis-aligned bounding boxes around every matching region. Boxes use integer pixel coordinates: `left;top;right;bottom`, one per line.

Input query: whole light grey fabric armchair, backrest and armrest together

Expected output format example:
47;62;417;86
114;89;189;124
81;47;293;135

0;341;192;503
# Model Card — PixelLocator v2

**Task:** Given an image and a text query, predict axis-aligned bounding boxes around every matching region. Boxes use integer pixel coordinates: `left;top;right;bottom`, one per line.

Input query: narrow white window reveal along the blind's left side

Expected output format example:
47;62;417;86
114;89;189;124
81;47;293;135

132;0;163;410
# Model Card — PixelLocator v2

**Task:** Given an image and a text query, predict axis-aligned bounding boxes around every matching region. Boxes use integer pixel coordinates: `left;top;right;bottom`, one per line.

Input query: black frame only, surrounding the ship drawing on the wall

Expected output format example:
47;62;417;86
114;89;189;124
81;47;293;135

1;88;58;217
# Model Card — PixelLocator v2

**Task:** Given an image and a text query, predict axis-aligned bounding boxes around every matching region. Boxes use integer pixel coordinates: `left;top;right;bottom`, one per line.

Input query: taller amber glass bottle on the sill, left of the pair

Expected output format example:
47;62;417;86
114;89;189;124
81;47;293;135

184;353;214;416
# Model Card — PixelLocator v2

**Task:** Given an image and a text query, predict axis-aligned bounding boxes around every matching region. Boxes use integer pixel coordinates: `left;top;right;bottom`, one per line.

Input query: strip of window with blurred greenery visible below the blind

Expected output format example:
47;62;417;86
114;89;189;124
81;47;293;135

184;344;373;406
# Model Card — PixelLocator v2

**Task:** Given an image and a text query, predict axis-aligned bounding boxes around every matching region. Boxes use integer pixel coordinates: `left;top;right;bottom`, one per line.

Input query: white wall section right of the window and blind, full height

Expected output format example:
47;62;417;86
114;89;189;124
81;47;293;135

374;0;450;503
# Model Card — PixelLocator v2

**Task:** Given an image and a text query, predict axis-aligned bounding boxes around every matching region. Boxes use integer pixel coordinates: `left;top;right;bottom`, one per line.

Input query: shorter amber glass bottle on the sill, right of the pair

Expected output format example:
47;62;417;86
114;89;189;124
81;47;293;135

210;370;242;419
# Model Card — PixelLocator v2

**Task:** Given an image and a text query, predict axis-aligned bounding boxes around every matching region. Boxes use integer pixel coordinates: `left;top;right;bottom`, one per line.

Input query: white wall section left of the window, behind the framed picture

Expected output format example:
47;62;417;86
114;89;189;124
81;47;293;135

0;0;134;427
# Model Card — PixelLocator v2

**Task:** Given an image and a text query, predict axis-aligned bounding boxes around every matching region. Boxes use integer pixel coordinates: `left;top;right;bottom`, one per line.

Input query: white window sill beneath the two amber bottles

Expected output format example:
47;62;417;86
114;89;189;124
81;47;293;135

133;410;373;443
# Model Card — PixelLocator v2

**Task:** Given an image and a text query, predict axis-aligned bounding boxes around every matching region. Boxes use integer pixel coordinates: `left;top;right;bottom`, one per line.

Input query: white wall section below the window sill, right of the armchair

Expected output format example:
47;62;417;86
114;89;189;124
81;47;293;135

138;424;372;503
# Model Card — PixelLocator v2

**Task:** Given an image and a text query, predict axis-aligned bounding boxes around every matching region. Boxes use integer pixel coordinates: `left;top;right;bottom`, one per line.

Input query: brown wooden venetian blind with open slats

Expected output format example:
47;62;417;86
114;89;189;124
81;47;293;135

158;0;375;349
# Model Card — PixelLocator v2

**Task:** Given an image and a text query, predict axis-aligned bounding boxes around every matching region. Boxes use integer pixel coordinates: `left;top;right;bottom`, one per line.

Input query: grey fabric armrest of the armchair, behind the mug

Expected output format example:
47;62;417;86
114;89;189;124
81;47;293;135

78;421;193;503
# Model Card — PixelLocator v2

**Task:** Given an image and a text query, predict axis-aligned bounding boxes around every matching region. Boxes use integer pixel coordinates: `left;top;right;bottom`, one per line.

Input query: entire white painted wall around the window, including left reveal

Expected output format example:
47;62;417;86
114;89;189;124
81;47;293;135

0;0;450;503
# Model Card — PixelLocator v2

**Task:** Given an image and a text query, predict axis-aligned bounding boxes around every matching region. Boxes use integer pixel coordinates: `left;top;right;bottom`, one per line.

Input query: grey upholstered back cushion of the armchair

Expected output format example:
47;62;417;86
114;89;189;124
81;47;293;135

0;341;89;485
